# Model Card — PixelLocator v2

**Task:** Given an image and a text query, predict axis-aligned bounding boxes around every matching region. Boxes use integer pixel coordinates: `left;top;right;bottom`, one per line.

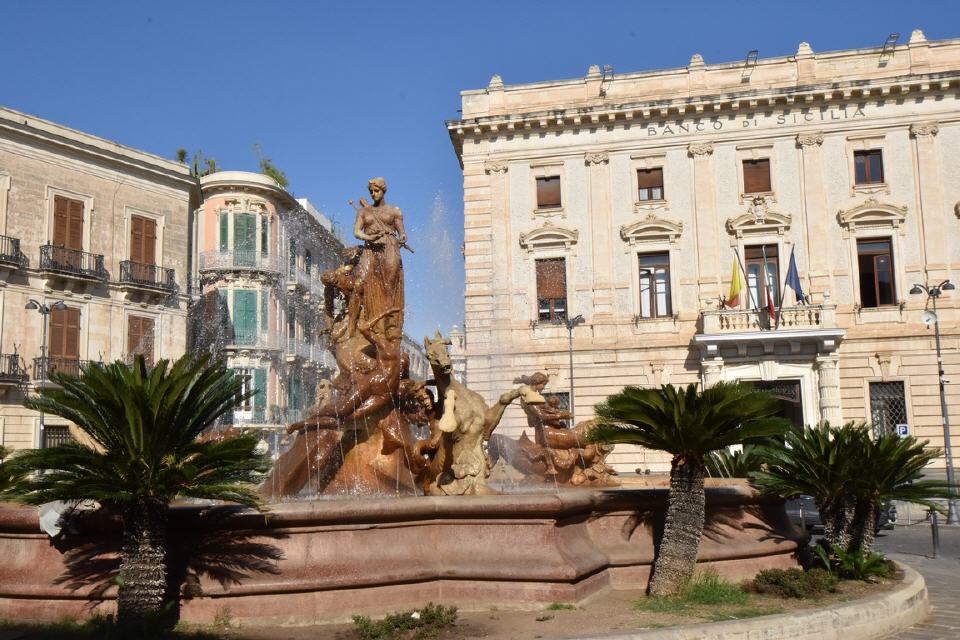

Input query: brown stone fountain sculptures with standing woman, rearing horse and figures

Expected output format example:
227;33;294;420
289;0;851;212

261;178;614;497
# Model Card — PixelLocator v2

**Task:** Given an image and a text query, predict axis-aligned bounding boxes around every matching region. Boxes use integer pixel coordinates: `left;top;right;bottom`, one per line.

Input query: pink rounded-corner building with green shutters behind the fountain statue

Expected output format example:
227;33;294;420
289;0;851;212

191;171;343;450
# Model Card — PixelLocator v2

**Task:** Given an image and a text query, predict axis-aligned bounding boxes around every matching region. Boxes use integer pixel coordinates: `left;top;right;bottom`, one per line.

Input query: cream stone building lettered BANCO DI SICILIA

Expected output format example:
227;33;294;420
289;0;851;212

447;31;960;471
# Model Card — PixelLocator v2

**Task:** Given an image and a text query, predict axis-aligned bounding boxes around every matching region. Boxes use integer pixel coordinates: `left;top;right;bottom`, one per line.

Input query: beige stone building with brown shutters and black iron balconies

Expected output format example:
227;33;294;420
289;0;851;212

0;108;196;449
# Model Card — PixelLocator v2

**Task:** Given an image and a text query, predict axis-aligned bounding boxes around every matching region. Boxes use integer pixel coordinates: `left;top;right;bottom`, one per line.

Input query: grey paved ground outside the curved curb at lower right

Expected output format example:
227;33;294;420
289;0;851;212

877;523;960;640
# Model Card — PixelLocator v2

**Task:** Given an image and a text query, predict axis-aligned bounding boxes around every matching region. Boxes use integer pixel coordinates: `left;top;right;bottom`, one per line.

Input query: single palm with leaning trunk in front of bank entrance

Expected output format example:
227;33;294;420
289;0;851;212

590;382;787;596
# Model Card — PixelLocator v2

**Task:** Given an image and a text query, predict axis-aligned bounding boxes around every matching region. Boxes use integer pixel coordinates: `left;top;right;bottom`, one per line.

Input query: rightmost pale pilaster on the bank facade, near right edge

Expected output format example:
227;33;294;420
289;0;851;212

910;122;950;280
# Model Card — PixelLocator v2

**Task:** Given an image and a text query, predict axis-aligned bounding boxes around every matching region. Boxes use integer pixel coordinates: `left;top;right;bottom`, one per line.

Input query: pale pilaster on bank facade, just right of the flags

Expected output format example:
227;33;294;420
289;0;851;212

797;131;834;300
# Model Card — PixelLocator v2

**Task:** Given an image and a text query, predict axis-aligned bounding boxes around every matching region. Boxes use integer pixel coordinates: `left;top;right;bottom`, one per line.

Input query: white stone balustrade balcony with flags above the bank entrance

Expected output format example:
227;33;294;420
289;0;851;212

694;305;846;357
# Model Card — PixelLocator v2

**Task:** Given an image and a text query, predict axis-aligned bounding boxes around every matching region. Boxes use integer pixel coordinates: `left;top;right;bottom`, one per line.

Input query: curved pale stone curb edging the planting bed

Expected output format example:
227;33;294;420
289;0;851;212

576;563;930;640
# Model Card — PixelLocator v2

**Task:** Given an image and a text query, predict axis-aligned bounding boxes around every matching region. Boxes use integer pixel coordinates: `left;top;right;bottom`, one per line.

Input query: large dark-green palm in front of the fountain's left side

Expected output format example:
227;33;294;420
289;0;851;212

4;354;268;627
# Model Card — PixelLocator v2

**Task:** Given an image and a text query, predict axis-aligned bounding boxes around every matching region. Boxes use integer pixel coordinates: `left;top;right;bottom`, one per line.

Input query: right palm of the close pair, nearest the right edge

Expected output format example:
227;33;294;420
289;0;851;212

848;430;950;553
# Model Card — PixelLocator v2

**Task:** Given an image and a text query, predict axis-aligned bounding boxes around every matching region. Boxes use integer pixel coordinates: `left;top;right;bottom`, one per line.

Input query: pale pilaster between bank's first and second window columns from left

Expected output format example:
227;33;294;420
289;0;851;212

583;151;614;322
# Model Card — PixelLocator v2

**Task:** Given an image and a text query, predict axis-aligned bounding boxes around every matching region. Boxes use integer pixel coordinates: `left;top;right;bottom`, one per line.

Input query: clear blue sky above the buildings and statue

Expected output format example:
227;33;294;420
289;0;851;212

0;0;960;338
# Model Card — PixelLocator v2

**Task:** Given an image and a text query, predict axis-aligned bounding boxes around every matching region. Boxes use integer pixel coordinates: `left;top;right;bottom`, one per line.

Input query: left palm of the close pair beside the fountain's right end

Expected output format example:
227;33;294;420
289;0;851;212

750;422;866;547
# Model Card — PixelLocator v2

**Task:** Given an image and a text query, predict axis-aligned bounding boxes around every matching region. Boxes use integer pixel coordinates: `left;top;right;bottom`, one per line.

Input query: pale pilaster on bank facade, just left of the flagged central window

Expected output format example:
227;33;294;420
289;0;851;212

687;142;716;309
